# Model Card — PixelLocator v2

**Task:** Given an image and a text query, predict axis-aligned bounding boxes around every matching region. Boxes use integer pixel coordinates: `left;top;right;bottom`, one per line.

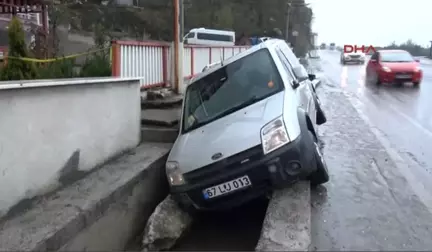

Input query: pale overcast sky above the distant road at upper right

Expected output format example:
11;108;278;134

306;0;432;46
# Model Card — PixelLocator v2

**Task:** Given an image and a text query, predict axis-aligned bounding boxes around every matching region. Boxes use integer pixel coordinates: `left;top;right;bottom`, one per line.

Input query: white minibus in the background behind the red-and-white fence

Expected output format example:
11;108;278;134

184;28;235;46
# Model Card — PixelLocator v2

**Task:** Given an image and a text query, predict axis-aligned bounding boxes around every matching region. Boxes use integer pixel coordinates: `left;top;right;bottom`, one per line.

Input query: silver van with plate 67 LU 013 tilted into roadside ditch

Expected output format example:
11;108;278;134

165;39;329;212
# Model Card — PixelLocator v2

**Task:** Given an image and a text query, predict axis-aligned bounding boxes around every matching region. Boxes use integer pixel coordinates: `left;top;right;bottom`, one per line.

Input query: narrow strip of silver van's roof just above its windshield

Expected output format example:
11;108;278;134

187;39;285;82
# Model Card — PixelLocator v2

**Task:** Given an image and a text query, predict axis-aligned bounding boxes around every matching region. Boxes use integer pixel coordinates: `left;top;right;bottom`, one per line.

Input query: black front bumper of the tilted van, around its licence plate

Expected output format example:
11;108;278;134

171;136;316;211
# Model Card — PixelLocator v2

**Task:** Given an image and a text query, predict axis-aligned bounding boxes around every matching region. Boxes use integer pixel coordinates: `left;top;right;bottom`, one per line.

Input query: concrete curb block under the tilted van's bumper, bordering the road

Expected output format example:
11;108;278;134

255;181;311;251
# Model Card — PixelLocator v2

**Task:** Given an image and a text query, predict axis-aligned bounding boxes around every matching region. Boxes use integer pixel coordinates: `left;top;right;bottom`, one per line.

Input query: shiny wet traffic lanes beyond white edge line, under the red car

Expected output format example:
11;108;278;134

321;51;432;189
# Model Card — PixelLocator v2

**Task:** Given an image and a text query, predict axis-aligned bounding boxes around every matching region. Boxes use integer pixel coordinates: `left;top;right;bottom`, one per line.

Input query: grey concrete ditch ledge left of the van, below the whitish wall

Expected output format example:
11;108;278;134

0;143;171;251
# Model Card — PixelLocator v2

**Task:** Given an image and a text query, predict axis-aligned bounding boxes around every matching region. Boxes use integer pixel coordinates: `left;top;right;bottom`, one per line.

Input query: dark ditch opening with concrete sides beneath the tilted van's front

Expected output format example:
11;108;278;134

142;182;311;251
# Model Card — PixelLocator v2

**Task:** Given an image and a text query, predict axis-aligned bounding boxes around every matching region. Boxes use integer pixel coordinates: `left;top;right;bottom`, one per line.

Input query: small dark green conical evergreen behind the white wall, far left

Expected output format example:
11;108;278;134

0;17;37;80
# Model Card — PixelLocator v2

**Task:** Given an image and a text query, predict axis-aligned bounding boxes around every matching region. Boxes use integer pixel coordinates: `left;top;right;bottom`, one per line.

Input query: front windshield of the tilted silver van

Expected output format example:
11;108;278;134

182;49;284;134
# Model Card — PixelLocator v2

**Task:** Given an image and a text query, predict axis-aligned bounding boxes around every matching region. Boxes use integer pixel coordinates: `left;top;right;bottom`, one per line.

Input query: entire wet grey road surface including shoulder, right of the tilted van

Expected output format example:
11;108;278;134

311;51;432;250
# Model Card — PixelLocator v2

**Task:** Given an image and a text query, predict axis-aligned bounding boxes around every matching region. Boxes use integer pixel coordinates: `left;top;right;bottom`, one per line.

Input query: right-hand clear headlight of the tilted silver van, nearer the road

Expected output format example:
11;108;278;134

261;117;290;154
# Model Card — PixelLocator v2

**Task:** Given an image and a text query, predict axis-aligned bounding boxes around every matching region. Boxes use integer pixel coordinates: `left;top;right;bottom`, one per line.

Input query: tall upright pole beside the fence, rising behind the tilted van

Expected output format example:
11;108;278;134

173;0;184;93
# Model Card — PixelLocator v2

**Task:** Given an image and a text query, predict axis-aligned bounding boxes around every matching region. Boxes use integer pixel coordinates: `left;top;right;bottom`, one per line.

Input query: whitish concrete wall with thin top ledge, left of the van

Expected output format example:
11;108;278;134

0;78;141;220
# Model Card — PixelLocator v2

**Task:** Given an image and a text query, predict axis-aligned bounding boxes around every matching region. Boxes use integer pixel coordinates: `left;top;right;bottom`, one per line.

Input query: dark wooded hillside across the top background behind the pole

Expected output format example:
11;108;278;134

58;0;312;55
